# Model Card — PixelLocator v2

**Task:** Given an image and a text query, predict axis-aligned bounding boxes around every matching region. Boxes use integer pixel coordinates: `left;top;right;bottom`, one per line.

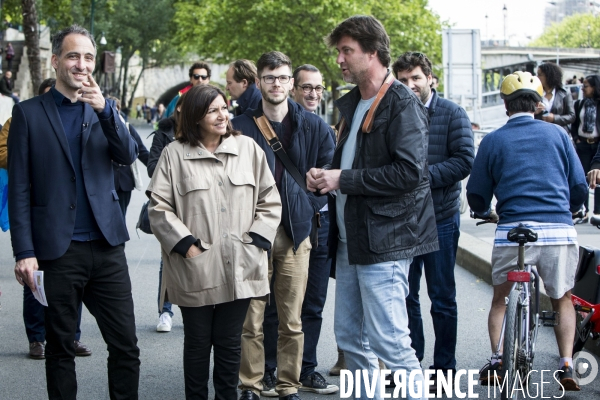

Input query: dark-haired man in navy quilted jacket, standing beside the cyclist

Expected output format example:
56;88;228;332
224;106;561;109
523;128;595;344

392;52;474;388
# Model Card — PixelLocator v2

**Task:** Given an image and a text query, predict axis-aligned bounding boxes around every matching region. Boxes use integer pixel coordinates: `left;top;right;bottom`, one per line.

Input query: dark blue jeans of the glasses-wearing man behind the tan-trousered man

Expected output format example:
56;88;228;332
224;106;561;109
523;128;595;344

263;211;331;379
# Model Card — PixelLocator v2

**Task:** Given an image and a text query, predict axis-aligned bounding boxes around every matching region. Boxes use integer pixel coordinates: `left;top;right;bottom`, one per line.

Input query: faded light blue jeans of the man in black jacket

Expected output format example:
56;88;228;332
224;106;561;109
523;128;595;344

334;241;425;400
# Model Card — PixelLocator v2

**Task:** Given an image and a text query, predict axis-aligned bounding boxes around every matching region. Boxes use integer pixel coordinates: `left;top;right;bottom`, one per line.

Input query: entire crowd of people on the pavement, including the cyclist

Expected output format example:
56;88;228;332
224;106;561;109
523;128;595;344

0;15;600;400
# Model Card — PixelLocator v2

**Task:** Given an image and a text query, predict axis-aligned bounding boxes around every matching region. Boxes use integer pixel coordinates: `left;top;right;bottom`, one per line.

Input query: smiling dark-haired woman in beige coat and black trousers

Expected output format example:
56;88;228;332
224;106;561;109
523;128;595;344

146;85;281;400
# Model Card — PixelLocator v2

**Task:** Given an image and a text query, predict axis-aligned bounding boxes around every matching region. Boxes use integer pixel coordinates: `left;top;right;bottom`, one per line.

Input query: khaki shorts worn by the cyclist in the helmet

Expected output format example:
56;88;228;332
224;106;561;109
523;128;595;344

492;244;579;299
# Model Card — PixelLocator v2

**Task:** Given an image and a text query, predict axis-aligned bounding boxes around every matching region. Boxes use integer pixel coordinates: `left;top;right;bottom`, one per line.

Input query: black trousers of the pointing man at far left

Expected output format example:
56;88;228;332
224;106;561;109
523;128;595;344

39;240;140;400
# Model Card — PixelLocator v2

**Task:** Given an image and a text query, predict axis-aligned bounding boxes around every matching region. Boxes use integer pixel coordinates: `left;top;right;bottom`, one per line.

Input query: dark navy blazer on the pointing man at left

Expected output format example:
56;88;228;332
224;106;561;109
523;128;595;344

8;91;137;260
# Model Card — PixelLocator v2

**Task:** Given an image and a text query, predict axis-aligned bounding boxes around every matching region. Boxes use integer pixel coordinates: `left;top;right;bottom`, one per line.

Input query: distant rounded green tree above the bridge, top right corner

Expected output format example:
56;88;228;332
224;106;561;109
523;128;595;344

529;14;600;48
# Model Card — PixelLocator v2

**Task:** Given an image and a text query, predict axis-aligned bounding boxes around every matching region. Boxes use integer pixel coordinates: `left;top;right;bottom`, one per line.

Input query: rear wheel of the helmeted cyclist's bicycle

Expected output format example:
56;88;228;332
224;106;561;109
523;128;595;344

502;289;521;400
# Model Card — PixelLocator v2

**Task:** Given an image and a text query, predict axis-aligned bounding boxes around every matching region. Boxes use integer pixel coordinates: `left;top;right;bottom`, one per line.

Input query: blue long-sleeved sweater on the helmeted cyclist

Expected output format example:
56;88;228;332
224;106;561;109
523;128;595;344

467;116;588;225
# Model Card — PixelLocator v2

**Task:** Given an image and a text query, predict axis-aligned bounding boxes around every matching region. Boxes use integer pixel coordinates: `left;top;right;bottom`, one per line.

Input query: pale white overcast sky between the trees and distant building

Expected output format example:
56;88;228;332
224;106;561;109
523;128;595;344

429;0;548;40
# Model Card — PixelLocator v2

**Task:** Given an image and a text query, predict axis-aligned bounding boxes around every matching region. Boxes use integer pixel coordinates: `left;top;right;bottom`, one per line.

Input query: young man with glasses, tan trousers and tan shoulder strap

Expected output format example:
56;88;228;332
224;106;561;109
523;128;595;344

232;51;334;400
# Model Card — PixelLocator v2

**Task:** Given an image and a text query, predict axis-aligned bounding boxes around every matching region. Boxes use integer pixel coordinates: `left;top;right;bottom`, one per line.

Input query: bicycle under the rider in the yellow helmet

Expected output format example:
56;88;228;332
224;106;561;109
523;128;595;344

471;212;556;400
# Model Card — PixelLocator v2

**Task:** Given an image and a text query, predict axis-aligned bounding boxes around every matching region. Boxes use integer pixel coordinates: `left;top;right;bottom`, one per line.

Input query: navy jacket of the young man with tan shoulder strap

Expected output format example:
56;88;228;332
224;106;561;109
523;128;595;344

231;99;335;251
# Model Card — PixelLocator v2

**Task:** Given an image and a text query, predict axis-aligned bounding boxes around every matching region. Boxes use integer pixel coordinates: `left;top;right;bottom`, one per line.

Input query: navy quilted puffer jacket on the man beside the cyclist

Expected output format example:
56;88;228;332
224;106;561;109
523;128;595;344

427;89;475;221
